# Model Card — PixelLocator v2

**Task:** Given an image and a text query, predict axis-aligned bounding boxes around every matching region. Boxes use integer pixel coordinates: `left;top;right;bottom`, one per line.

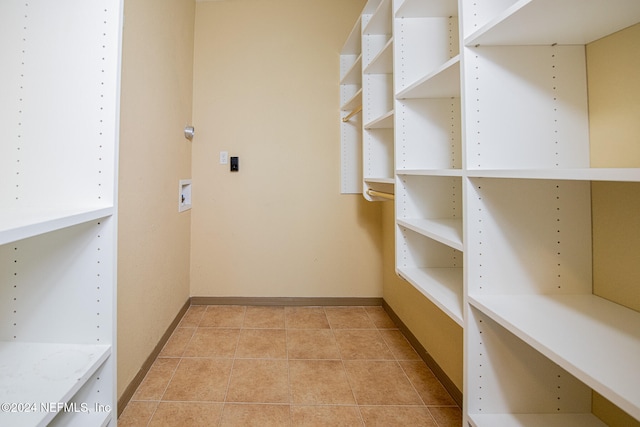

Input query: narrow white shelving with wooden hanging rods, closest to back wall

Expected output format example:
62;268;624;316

340;0;395;201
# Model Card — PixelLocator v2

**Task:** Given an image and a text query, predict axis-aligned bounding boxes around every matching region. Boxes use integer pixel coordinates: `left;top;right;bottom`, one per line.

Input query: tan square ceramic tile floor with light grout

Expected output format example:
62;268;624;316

118;306;462;427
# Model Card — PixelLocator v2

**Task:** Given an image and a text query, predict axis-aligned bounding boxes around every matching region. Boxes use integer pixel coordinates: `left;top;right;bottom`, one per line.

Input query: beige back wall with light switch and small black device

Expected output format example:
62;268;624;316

191;0;382;297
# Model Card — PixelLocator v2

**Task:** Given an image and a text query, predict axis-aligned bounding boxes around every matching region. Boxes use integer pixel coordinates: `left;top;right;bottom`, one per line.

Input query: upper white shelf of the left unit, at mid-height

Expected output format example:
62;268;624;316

0;207;114;245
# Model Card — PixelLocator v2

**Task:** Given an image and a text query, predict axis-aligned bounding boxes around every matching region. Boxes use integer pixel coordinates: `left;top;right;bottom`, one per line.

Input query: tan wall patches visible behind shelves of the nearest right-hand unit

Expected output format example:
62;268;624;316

587;24;640;427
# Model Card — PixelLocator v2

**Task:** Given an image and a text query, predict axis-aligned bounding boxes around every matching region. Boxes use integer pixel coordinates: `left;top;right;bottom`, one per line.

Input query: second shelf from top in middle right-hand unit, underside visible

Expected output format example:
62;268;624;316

396;55;460;99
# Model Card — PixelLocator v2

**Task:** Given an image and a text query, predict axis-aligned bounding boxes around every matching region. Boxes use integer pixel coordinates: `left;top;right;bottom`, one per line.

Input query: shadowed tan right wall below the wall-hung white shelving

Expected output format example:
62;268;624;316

383;202;463;390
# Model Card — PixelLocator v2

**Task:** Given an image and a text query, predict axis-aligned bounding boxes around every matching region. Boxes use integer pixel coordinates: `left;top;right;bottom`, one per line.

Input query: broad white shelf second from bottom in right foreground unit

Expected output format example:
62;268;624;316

469;295;640;419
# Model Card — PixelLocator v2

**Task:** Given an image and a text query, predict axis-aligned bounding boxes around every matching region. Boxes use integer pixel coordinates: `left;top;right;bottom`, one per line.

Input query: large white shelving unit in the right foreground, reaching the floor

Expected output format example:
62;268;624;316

461;0;640;426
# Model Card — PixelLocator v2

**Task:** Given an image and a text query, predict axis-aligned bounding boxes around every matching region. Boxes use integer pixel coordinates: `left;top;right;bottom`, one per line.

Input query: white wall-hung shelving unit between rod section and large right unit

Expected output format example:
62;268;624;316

394;0;464;328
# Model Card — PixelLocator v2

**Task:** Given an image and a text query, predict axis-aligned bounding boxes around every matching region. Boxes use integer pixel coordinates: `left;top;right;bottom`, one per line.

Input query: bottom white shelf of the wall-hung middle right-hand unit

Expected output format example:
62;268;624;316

397;267;463;326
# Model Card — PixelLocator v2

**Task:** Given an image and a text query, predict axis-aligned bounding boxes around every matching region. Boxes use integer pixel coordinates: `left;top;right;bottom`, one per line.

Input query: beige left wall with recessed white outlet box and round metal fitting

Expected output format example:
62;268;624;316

117;0;197;397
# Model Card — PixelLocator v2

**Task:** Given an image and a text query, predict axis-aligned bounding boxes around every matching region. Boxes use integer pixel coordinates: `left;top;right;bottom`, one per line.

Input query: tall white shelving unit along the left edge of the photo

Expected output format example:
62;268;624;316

0;0;122;426
